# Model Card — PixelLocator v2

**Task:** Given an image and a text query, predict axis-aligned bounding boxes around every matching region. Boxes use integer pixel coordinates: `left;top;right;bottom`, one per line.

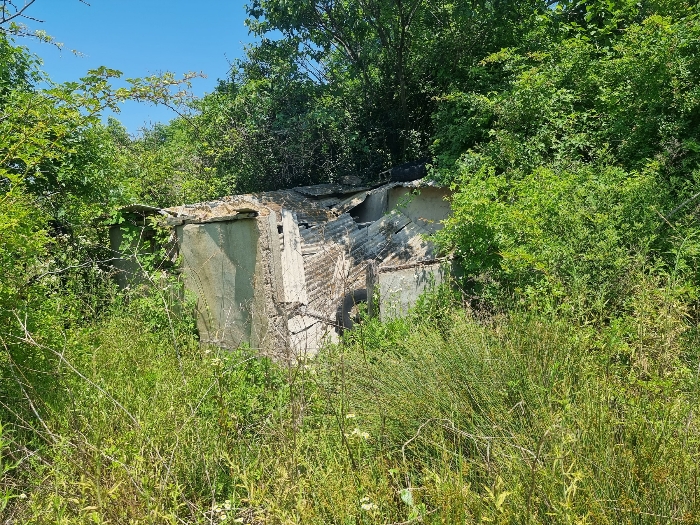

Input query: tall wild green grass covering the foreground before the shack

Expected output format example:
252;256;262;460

0;282;700;525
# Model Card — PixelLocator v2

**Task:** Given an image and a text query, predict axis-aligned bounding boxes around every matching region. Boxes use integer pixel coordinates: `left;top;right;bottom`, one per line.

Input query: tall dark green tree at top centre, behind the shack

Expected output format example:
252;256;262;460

249;0;546;163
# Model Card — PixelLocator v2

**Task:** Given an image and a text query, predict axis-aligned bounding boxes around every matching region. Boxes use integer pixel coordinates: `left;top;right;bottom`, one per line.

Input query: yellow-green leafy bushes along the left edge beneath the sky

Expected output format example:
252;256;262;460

0;36;197;344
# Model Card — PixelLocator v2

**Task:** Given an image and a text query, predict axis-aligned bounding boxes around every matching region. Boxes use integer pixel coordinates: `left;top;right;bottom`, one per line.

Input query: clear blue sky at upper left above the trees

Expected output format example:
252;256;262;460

17;0;253;134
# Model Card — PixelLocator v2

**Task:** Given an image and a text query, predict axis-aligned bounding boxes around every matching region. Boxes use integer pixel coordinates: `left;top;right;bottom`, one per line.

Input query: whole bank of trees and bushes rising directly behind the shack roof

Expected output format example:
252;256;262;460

127;0;546;204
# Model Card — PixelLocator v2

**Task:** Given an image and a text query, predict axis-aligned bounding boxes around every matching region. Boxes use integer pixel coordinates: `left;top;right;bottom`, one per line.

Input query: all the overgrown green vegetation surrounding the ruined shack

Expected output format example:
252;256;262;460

0;0;700;524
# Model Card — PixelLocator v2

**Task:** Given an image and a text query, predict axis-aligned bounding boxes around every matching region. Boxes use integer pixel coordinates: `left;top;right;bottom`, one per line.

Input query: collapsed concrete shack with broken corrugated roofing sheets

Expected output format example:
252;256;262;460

110;179;451;360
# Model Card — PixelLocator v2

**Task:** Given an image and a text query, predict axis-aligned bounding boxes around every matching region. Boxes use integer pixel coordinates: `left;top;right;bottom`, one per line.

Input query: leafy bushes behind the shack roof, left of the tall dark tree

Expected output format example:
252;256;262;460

126;36;394;200
